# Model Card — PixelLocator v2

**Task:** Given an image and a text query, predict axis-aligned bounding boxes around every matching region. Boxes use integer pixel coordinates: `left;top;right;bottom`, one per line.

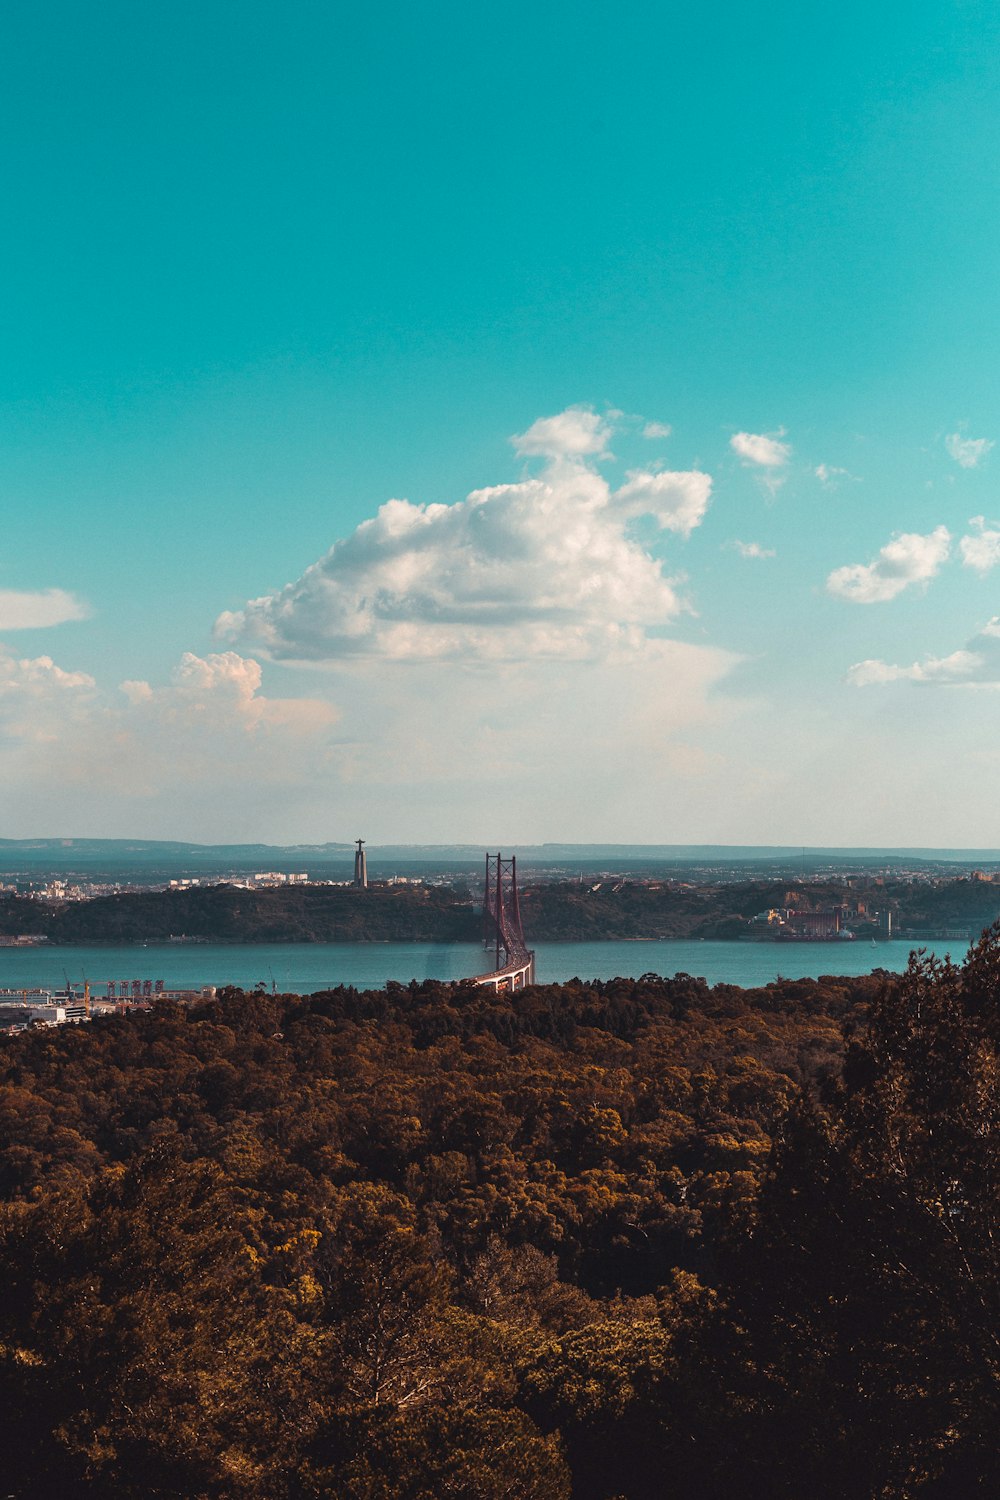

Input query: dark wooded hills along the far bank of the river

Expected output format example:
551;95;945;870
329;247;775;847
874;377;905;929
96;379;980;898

0;879;1000;944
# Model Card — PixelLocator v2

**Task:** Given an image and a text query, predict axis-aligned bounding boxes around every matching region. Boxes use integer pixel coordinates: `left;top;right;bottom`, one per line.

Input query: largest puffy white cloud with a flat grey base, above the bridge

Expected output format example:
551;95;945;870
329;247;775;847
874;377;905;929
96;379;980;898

217;407;712;663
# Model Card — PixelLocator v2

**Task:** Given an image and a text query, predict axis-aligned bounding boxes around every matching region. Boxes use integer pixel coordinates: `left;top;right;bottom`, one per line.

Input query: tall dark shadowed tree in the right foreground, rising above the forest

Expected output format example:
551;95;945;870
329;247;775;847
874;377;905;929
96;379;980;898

689;927;1000;1500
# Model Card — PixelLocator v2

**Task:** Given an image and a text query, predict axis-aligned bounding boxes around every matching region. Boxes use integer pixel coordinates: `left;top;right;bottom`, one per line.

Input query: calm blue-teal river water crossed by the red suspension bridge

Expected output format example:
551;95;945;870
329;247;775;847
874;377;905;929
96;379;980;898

0;941;966;995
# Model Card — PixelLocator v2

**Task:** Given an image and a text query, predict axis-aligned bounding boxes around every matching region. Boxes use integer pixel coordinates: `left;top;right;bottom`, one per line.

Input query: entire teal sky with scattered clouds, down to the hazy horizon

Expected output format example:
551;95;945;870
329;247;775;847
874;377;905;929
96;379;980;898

0;0;1000;848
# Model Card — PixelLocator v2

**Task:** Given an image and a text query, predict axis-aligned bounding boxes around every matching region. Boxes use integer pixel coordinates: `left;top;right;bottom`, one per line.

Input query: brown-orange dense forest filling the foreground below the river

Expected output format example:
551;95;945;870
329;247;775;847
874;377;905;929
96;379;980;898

0;930;1000;1500
